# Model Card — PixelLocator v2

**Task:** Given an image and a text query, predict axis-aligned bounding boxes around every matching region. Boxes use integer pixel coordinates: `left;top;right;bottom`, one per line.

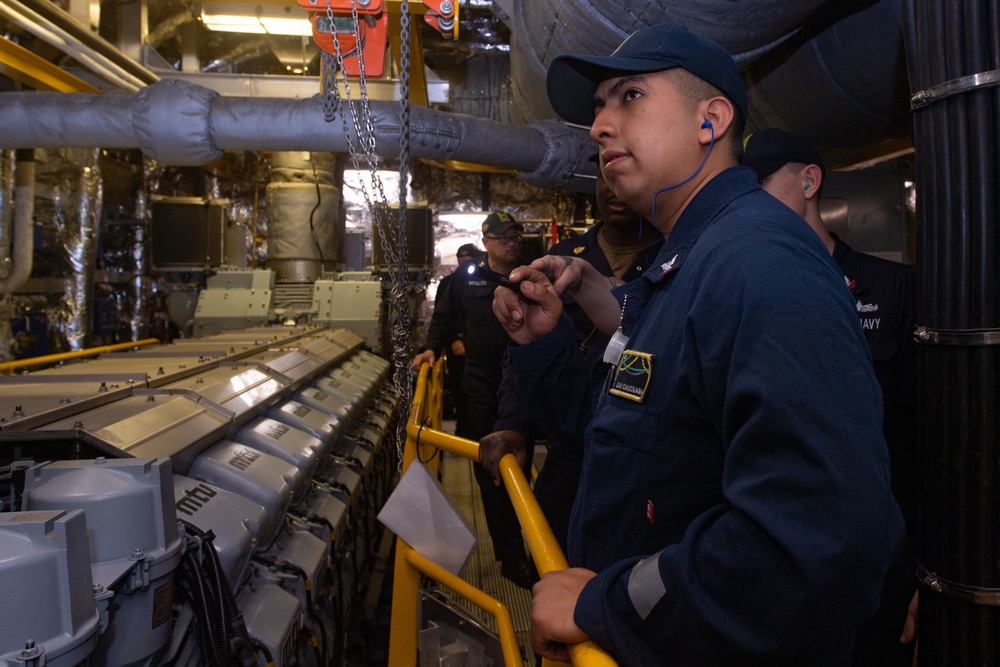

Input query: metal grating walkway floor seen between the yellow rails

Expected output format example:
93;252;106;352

441;452;535;667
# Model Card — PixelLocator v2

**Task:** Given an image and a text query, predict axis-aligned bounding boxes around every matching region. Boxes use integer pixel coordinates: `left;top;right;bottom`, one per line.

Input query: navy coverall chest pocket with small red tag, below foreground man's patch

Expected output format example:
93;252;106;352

582;396;661;559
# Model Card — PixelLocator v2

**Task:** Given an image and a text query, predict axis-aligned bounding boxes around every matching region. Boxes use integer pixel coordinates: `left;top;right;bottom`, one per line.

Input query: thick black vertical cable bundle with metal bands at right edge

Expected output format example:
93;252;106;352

904;0;1000;667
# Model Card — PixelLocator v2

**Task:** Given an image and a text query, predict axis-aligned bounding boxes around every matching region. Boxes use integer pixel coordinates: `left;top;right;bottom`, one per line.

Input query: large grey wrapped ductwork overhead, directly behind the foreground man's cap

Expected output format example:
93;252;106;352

510;0;910;165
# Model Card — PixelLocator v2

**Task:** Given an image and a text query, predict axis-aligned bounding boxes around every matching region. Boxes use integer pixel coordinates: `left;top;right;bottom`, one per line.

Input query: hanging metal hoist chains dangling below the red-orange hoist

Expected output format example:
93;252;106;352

322;0;413;472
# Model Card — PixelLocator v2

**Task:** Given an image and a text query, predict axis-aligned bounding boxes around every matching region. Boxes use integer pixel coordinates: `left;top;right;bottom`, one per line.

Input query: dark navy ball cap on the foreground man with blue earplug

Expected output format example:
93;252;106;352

545;23;747;125
